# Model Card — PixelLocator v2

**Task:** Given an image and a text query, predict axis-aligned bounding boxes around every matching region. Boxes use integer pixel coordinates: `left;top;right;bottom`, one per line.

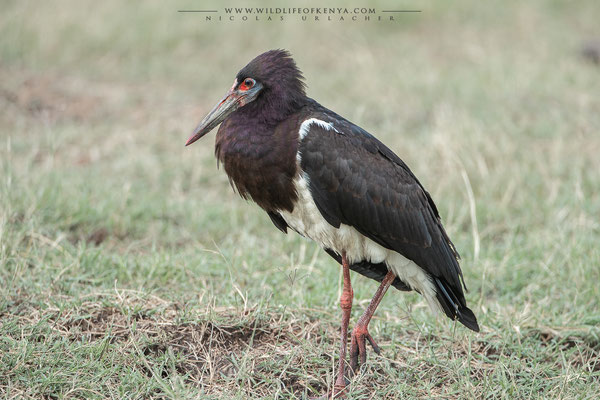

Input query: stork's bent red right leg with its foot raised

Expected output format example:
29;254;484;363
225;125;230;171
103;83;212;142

350;271;396;372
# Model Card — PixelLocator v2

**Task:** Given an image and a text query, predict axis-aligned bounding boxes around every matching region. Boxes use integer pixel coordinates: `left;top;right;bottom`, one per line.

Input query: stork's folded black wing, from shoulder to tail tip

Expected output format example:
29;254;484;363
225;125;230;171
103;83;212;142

299;114;479;330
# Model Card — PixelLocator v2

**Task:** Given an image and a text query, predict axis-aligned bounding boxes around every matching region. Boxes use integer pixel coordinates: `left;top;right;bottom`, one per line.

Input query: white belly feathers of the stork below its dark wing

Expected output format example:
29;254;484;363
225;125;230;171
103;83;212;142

278;170;441;312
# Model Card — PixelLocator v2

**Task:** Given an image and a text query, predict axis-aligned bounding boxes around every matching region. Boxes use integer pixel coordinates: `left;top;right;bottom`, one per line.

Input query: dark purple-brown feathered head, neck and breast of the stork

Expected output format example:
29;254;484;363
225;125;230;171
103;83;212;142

215;50;309;211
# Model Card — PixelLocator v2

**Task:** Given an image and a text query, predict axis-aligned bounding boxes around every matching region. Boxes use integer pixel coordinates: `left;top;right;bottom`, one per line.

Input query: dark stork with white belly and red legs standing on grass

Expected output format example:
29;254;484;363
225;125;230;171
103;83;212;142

186;50;479;397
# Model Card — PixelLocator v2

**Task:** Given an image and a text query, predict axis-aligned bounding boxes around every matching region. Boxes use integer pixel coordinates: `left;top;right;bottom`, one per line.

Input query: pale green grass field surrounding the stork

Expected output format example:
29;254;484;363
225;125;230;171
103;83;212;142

0;0;600;399
